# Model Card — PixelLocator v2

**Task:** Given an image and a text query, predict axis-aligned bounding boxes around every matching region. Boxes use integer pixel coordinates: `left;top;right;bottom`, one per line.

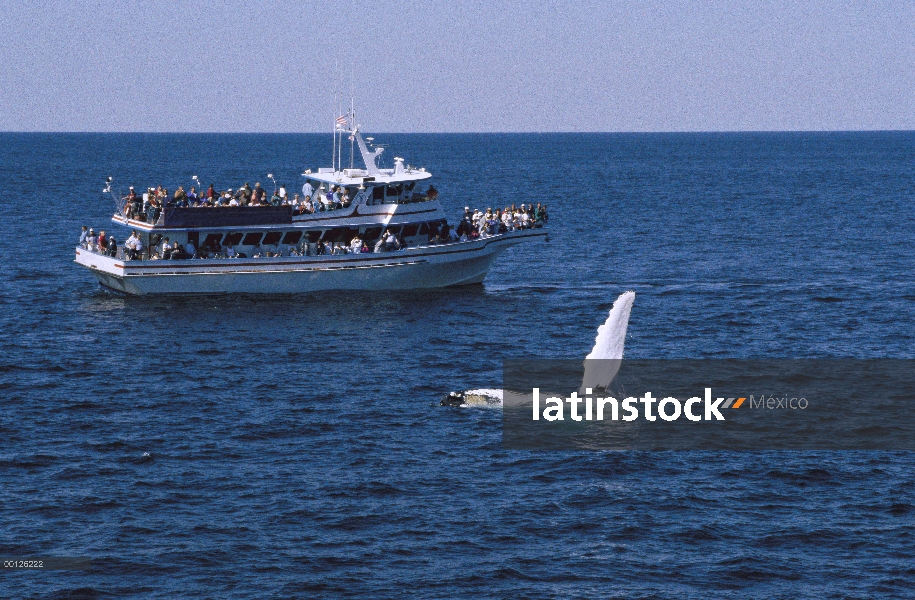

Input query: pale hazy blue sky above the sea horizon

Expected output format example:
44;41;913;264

0;0;915;132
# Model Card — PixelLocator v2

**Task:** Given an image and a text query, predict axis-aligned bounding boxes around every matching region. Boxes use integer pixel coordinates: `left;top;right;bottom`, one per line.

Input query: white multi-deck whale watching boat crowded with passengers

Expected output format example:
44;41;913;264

76;117;547;295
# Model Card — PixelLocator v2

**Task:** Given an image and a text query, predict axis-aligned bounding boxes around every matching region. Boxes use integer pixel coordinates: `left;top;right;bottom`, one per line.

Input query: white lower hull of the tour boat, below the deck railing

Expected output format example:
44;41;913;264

76;229;547;295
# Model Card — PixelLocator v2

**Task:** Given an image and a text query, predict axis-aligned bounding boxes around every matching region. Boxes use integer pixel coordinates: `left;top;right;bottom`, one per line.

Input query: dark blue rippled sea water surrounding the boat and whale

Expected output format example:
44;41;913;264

0;133;915;598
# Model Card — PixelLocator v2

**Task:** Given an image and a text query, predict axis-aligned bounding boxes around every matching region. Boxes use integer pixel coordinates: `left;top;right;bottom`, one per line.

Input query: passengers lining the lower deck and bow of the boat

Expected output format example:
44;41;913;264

79;203;549;260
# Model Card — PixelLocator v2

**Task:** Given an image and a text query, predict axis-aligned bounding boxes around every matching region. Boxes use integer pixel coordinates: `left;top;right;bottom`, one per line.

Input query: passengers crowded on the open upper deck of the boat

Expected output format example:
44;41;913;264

122;182;438;223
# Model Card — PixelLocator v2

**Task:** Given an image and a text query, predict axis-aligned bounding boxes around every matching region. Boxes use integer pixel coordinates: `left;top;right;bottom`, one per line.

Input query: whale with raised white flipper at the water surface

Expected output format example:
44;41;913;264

450;291;635;406
